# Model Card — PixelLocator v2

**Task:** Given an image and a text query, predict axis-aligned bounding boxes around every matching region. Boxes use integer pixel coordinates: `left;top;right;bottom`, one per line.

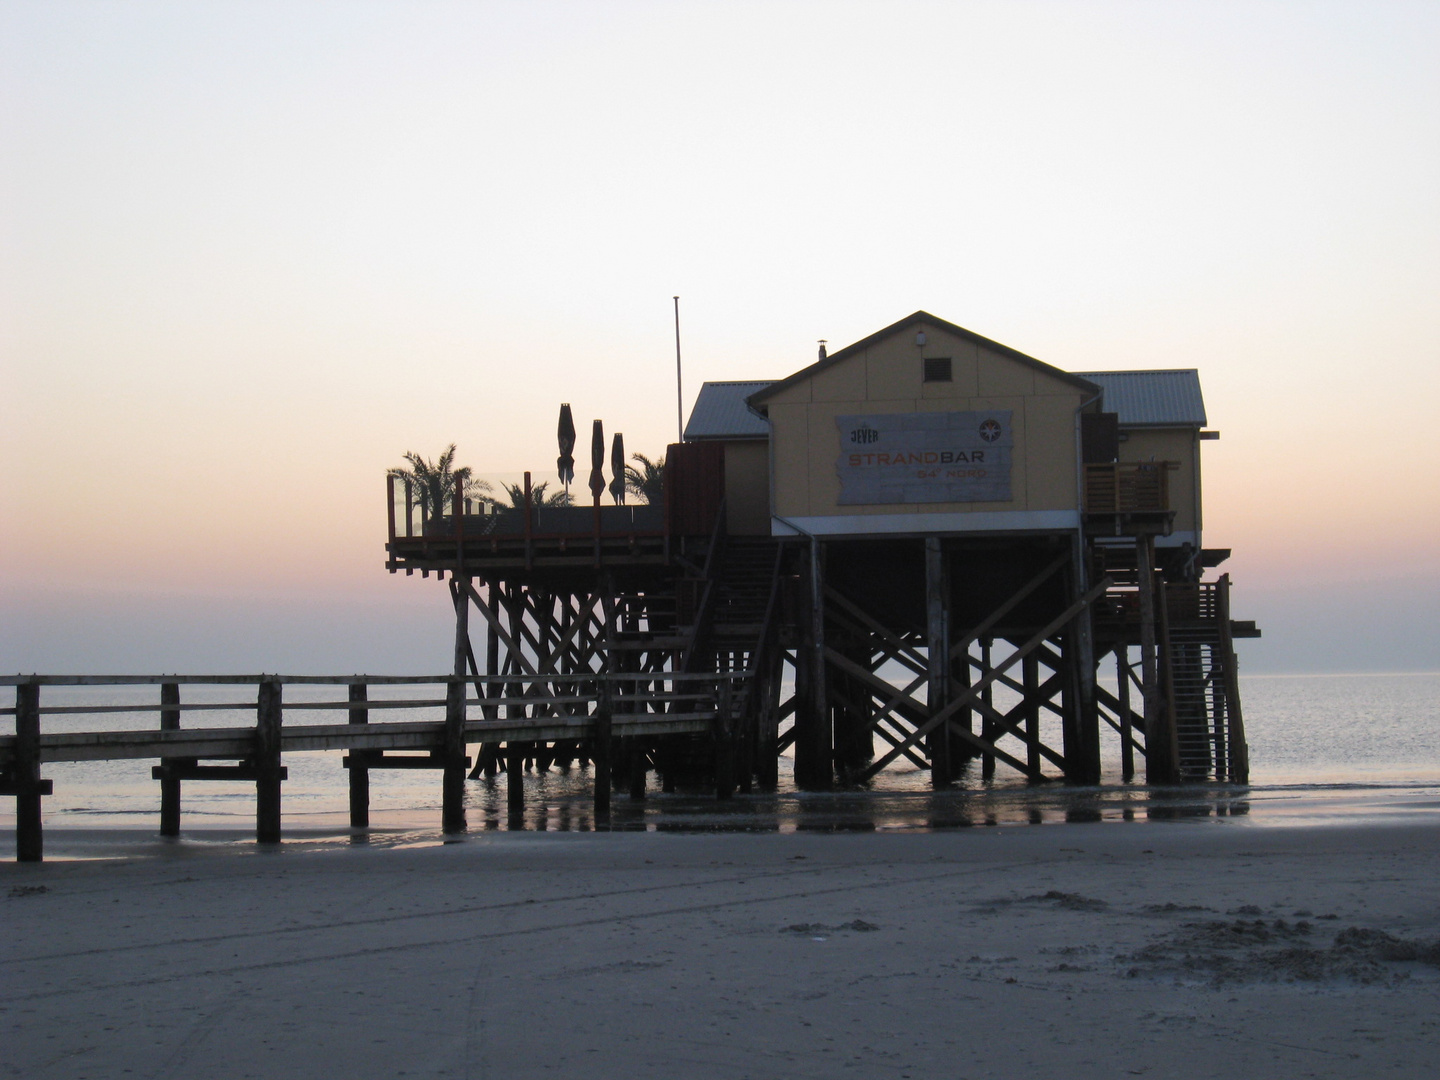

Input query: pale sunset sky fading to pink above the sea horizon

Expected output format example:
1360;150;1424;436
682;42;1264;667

0;0;1440;672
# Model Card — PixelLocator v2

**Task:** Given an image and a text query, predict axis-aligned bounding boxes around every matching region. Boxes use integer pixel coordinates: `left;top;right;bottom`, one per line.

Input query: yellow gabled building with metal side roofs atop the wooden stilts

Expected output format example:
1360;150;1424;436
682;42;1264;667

685;311;1211;552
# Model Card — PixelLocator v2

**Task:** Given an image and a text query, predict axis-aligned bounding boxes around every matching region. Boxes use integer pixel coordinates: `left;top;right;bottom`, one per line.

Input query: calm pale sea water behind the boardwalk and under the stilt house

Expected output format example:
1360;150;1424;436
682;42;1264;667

0;674;1440;857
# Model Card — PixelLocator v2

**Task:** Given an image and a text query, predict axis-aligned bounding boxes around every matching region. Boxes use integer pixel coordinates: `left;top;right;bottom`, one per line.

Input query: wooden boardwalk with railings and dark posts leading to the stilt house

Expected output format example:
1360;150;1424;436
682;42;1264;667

0;671;752;861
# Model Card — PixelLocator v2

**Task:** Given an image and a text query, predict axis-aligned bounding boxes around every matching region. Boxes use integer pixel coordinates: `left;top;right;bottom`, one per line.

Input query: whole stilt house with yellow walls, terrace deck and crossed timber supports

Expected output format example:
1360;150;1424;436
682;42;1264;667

389;311;1257;792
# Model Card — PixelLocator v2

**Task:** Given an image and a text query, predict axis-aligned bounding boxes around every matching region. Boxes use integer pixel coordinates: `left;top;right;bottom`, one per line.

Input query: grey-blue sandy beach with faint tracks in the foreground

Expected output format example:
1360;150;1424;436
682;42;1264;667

0;822;1440;1080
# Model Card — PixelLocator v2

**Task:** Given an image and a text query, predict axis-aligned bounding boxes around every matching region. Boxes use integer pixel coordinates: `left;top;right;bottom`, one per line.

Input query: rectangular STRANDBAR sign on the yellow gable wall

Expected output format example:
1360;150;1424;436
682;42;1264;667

835;409;1015;505
